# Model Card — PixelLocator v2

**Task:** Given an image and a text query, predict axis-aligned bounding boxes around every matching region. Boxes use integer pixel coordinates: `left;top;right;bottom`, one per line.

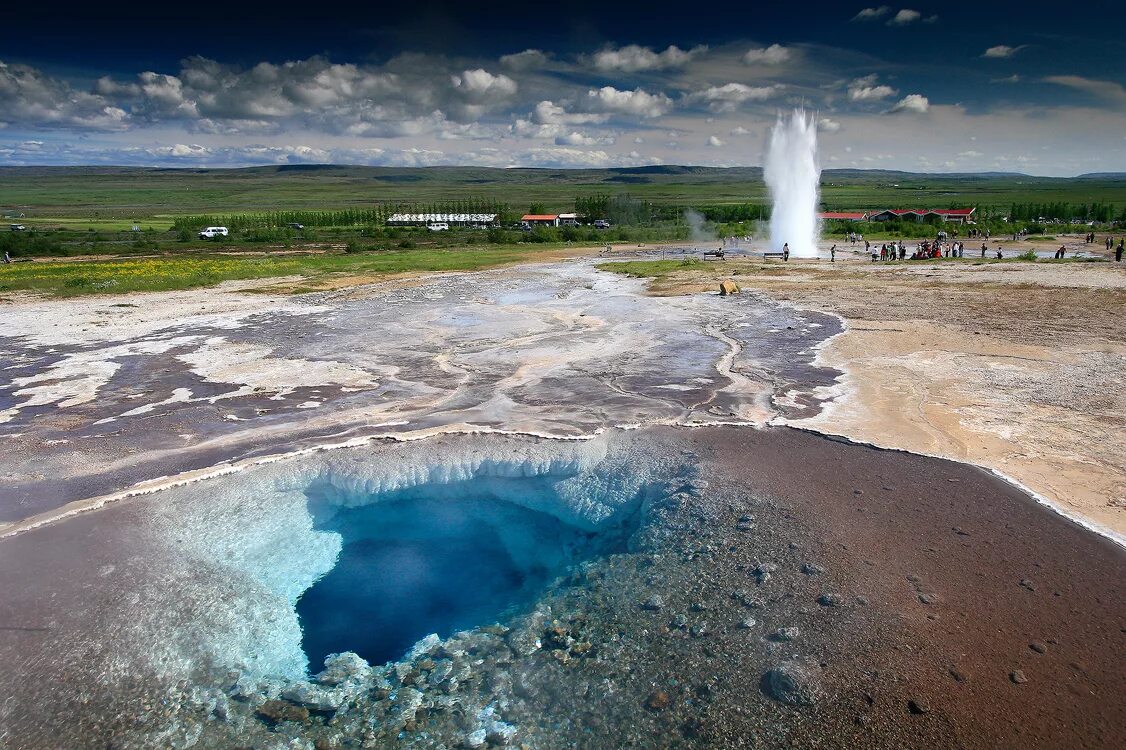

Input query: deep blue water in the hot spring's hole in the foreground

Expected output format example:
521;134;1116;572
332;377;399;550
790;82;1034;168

297;476;632;666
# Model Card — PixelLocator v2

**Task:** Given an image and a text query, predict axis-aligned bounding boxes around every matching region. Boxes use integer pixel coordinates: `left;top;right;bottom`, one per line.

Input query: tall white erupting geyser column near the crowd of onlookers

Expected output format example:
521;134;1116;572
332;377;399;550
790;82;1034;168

763;109;821;258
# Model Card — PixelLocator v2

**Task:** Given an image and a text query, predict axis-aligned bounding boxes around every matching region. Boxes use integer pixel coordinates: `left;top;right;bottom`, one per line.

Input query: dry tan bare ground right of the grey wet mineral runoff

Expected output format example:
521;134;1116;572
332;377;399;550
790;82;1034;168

626;247;1126;539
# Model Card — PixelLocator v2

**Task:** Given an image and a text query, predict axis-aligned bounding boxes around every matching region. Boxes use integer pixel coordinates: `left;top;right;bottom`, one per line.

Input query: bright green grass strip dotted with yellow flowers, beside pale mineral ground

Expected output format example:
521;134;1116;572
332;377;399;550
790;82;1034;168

0;247;572;296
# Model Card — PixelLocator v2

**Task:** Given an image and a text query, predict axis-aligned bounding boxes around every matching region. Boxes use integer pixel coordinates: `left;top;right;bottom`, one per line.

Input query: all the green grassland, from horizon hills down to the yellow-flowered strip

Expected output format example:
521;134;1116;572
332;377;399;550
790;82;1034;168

0;167;1126;295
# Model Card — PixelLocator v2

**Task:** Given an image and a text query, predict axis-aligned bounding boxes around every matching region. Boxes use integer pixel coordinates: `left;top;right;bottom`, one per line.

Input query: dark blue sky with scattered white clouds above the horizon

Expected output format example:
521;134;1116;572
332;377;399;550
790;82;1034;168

0;0;1126;176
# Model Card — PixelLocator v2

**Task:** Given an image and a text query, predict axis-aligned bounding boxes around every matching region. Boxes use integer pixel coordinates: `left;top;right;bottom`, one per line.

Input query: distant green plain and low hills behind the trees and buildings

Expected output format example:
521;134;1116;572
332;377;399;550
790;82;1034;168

0;166;1126;219
